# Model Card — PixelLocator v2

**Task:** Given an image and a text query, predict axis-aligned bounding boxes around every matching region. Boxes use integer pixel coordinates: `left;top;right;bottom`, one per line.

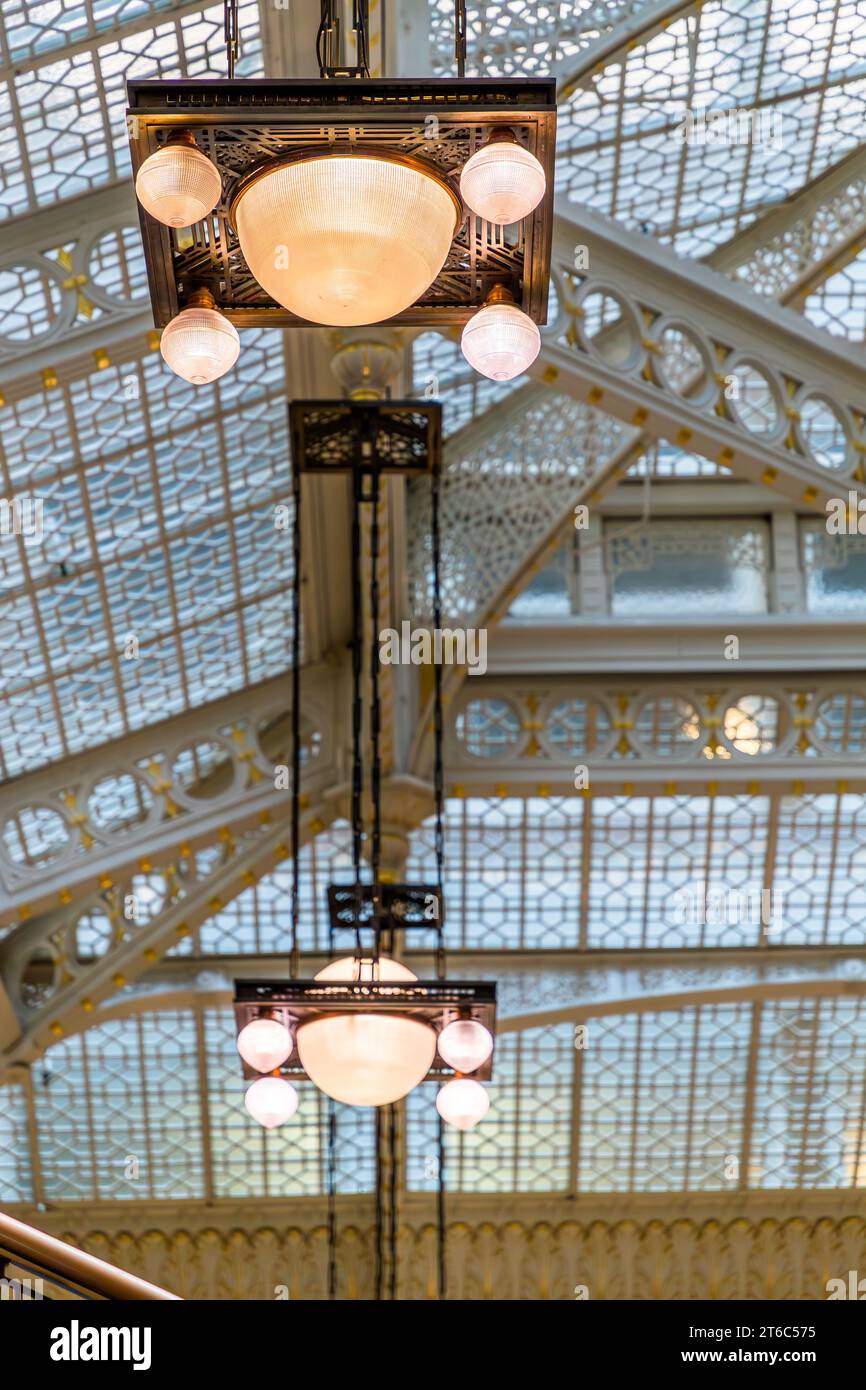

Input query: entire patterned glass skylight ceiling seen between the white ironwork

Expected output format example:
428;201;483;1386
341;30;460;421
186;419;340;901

0;0;866;1217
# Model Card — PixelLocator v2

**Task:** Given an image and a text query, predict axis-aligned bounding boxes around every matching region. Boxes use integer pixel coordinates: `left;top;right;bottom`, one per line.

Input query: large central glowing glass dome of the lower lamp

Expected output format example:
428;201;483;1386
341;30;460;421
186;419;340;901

297;956;436;1105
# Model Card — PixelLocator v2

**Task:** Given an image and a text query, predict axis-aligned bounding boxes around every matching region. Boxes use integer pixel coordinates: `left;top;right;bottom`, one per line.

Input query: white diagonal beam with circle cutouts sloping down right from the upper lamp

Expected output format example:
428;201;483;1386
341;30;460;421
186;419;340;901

535;202;866;509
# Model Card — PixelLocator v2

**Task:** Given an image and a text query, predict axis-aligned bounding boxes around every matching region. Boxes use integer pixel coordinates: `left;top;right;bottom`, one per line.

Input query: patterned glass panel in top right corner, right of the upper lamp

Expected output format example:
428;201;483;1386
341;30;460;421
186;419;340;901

557;0;866;256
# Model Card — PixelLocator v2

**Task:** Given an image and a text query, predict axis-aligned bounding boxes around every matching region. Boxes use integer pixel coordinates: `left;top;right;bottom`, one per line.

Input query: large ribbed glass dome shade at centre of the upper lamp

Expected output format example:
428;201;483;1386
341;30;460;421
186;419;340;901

234;154;457;325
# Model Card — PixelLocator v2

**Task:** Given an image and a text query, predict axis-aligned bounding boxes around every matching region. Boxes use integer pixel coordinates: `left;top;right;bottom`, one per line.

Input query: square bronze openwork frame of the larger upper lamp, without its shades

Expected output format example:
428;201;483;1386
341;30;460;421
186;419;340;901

126;78;556;328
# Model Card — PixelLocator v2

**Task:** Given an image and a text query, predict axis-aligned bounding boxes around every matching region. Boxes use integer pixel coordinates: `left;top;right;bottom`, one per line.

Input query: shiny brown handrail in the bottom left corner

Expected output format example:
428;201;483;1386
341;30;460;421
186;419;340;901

0;1212;178;1301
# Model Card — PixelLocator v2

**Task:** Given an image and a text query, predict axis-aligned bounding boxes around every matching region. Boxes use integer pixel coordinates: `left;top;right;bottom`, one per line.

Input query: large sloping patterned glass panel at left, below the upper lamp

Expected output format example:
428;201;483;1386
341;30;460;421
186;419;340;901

0;329;292;777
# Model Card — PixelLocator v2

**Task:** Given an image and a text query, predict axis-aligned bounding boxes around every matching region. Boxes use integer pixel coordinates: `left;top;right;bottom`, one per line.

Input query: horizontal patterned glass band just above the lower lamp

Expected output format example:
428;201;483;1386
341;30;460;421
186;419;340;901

77;792;866;956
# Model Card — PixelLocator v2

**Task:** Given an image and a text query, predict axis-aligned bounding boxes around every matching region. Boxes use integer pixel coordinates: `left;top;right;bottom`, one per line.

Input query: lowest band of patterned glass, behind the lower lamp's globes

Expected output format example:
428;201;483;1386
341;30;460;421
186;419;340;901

0;991;866;1204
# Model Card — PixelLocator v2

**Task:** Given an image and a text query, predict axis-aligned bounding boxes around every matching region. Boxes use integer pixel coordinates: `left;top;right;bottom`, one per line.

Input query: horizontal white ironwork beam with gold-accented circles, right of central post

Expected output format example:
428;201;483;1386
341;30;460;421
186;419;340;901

446;673;866;795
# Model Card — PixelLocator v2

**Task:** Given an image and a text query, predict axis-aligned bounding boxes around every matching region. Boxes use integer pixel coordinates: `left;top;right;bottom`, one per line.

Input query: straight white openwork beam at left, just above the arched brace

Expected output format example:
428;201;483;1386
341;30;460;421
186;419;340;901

0;663;346;926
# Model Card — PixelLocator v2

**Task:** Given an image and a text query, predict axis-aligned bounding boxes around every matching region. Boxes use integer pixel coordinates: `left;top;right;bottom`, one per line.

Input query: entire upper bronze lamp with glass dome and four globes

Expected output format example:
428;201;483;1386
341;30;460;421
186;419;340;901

128;0;556;384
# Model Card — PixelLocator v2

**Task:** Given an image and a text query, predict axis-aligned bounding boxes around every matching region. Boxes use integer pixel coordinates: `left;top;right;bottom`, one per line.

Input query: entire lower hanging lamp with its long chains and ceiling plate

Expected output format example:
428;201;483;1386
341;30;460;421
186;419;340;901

235;400;496;1127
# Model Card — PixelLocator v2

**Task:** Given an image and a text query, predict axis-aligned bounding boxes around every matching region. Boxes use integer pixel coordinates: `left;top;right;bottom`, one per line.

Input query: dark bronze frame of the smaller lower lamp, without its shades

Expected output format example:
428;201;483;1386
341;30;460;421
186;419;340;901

234;980;496;1081
